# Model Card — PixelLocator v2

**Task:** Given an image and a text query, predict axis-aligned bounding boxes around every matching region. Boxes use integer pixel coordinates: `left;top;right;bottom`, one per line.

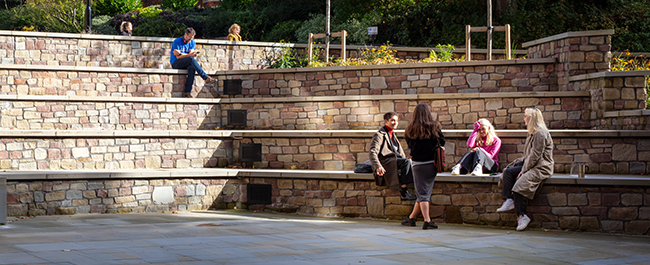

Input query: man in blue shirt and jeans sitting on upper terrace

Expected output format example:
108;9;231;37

169;28;216;97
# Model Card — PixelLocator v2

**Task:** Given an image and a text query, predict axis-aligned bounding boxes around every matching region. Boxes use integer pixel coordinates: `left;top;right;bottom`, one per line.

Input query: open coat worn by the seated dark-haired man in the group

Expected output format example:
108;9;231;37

370;126;406;186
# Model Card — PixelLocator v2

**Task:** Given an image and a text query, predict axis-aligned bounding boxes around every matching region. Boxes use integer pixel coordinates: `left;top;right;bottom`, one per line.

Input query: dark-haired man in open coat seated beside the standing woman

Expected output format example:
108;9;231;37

370;112;415;200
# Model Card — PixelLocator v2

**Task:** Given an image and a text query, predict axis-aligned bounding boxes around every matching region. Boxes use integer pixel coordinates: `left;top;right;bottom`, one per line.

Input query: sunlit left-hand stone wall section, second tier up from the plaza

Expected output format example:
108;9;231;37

0;137;232;170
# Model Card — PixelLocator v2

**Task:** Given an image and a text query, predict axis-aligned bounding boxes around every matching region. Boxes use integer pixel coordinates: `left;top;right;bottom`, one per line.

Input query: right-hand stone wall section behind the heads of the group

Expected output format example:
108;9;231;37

221;95;591;130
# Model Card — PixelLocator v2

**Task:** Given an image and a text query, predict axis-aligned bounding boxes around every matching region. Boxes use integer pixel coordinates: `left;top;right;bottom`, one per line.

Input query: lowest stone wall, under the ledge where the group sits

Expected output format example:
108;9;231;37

2;178;650;235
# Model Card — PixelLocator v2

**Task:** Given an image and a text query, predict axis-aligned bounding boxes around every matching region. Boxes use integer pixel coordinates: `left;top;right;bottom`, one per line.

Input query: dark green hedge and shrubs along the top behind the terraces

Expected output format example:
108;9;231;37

0;0;650;52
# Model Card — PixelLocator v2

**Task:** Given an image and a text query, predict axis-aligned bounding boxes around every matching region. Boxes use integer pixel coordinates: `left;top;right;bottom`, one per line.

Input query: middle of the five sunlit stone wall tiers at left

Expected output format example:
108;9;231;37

0;101;221;130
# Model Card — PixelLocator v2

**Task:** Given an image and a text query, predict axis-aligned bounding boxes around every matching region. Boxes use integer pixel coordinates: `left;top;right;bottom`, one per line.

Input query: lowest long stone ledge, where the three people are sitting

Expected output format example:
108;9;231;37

0;168;650;186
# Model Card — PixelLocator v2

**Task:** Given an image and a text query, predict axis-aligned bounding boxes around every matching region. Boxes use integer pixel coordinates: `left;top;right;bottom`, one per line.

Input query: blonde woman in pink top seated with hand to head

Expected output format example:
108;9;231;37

451;119;501;176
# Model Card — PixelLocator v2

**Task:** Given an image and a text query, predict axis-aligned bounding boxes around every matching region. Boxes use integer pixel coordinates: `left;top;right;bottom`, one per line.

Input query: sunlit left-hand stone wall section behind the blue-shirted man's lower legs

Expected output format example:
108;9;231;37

0;65;216;97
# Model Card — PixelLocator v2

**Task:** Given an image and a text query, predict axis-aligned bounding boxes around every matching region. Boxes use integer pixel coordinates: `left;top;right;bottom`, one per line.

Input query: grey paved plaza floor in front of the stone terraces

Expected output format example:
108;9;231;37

0;210;650;264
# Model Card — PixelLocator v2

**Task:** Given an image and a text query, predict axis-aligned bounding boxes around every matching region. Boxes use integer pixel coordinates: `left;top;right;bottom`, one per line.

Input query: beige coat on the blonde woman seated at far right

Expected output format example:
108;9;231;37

504;130;555;200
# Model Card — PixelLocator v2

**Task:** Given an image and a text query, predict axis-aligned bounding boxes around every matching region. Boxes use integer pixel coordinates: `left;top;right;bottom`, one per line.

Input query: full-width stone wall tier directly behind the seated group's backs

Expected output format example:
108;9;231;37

0;131;650;174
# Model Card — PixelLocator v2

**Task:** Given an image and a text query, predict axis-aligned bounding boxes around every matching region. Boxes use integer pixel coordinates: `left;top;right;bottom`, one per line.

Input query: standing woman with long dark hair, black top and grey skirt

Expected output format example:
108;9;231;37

402;103;445;230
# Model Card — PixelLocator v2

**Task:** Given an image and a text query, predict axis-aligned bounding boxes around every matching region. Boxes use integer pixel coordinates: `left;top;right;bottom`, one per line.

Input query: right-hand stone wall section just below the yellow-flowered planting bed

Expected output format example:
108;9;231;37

217;62;557;97
